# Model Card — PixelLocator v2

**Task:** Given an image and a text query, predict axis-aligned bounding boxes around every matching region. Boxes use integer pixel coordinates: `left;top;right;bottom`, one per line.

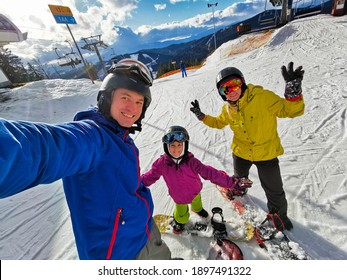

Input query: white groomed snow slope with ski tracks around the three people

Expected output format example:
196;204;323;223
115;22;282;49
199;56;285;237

0;15;347;260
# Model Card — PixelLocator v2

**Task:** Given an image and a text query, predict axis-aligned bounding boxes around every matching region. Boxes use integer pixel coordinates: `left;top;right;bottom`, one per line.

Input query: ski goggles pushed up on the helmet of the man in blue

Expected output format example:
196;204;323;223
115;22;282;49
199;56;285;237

108;58;153;86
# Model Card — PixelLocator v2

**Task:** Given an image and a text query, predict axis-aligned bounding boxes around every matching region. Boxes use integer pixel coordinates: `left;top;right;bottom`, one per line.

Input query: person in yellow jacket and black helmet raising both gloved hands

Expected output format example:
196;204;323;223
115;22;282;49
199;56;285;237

190;62;305;230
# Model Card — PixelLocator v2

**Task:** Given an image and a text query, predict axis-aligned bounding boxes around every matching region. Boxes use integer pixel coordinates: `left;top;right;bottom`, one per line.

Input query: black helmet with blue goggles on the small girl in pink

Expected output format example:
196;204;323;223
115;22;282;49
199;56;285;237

162;125;189;158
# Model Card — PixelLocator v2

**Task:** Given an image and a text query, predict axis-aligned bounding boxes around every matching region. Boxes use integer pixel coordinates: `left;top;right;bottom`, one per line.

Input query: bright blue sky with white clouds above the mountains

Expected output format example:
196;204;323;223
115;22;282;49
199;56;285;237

0;0;258;60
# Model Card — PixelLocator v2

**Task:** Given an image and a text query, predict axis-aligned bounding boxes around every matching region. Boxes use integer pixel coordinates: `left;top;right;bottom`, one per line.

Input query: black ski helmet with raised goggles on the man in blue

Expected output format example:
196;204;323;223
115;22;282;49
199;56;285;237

97;58;153;131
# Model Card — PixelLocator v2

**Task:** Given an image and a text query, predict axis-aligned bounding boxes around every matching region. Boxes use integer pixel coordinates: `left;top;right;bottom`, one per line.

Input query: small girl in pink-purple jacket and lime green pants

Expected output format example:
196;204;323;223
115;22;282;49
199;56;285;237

141;126;251;233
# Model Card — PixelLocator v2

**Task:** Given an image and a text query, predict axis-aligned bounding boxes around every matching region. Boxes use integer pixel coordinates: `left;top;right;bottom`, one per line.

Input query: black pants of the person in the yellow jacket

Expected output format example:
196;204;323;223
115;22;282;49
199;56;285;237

233;154;288;216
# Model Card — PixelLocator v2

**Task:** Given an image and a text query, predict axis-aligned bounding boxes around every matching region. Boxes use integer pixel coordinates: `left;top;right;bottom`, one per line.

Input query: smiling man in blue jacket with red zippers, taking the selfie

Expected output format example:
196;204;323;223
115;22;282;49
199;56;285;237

0;59;171;260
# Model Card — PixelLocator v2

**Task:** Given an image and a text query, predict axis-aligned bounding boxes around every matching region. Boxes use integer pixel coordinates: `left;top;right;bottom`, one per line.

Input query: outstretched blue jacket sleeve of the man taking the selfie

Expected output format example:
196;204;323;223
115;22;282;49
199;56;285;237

0;119;102;198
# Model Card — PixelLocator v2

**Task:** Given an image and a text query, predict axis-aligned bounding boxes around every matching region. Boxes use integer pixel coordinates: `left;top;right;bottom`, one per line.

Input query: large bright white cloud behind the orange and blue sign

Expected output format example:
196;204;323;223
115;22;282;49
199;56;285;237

1;0;138;60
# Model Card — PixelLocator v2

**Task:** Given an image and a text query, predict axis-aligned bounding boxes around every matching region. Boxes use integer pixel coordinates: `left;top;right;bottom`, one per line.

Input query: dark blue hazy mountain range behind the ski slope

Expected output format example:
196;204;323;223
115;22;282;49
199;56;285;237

49;0;334;79
